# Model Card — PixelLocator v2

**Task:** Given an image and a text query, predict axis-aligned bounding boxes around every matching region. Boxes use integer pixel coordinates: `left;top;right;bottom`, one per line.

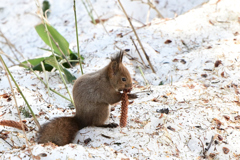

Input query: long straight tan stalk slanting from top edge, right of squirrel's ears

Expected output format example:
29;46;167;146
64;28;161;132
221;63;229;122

118;0;156;73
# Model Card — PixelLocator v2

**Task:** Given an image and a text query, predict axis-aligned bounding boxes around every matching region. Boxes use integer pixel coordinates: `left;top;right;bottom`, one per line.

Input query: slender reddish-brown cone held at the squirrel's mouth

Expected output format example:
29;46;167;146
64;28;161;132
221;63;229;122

120;90;129;127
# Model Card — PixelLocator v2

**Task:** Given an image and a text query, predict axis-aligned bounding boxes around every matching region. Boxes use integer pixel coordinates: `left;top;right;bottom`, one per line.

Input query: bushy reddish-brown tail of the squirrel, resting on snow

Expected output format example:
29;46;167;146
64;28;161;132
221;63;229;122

37;116;83;146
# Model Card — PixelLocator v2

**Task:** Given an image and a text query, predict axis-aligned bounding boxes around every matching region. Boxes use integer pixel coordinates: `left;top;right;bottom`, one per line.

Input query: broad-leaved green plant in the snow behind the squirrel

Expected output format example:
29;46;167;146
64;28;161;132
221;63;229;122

20;24;83;83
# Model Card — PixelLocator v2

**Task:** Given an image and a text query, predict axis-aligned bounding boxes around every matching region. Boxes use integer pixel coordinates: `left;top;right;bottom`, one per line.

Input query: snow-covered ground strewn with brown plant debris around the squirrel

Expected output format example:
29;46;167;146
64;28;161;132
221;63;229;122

0;0;240;159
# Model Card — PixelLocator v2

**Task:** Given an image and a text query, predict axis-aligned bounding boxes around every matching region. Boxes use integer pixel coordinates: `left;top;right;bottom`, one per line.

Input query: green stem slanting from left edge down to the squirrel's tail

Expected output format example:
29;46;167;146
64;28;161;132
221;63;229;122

0;55;40;129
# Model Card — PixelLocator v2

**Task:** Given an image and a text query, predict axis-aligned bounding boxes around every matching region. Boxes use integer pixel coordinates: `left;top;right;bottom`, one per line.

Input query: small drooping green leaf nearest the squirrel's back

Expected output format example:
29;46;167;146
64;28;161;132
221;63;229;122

45;56;76;83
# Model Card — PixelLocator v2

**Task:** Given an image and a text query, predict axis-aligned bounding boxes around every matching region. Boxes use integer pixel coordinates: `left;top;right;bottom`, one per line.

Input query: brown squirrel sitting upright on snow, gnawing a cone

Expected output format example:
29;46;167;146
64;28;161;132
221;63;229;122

37;50;137;146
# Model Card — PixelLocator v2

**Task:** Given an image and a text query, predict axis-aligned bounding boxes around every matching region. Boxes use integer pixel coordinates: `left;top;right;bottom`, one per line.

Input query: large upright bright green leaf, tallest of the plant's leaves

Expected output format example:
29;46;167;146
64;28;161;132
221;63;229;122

35;24;69;56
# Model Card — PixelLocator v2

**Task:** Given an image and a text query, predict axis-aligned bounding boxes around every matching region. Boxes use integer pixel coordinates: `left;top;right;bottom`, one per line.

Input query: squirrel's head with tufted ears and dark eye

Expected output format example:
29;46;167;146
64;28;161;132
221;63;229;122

108;50;132;91
